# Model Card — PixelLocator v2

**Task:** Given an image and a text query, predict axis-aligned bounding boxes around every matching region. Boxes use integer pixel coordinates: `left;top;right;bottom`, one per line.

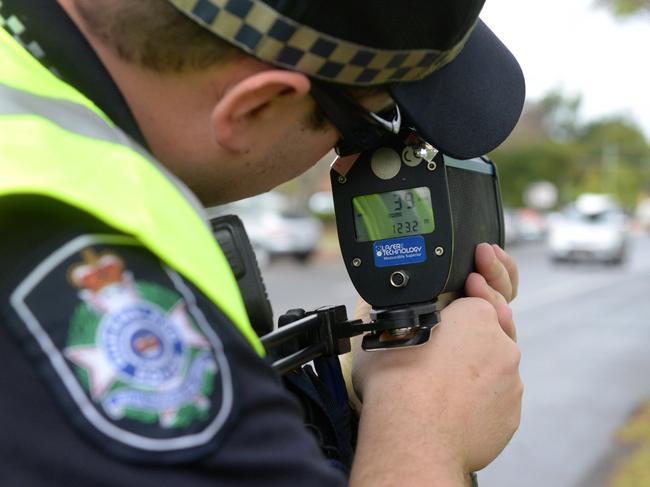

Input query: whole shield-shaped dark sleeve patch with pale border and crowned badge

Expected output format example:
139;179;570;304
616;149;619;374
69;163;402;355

11;236;232;460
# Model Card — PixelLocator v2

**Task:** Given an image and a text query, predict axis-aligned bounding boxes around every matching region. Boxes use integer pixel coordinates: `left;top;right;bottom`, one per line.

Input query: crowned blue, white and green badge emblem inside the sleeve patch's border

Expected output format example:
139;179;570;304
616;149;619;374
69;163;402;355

64;249;217;428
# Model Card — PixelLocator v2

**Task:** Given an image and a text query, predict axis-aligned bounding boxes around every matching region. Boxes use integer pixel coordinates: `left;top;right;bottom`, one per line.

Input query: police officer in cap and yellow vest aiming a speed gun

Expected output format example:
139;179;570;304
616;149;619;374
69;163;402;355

0;0;523;486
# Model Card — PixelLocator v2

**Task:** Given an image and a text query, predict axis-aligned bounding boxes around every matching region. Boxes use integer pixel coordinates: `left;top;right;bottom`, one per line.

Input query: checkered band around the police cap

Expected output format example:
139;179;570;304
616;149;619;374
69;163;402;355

169;0;471;86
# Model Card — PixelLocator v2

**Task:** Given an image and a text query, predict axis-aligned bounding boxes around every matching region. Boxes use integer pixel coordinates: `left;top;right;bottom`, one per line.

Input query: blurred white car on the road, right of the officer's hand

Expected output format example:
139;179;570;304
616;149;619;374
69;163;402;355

548;193;627;264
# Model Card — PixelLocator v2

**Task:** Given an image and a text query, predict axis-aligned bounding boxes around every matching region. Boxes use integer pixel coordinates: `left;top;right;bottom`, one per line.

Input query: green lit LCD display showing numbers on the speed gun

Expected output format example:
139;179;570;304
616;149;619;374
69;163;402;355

352;187;435;242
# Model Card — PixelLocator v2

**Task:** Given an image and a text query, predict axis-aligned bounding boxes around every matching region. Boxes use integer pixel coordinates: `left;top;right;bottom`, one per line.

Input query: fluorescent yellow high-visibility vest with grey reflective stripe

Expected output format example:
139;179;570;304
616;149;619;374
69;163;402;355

0;28;264;355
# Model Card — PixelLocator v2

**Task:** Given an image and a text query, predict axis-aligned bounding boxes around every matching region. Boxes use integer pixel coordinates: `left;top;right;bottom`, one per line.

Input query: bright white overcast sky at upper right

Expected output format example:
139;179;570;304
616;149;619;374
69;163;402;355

481;0;650;139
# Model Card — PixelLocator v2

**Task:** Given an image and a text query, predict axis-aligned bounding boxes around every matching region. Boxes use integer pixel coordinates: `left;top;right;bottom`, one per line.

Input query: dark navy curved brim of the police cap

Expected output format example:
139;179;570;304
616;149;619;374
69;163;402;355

390;20;526;159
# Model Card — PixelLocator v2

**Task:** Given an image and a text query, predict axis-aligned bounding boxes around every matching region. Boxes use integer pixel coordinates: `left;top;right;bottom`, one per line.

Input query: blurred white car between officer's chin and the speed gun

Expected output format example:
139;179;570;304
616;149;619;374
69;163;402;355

209;192;322;266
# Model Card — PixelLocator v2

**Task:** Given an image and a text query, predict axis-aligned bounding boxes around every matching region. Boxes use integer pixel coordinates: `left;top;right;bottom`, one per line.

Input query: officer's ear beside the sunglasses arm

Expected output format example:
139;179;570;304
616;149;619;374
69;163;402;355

212;69;310;153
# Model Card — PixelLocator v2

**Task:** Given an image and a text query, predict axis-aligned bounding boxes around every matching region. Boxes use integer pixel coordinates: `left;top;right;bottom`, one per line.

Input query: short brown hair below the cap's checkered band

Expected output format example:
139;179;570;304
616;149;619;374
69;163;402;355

75;0;245;73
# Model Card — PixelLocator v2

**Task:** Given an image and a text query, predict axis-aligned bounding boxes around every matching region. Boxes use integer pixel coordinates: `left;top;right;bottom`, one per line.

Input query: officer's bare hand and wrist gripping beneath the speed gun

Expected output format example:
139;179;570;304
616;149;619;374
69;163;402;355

352;298;523;485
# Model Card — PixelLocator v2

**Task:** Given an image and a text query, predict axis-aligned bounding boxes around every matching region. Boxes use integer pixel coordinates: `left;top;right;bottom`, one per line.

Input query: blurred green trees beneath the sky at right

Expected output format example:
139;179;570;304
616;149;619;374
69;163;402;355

490;92;650;208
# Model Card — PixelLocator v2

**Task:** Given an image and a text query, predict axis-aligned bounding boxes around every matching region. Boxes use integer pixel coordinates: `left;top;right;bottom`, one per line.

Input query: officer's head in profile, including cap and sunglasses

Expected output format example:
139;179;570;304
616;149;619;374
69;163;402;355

60;0;524;206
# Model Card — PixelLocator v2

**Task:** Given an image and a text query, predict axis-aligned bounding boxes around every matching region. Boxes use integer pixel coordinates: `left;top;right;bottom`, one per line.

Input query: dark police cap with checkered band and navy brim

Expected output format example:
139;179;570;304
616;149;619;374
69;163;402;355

168;0;525;159
